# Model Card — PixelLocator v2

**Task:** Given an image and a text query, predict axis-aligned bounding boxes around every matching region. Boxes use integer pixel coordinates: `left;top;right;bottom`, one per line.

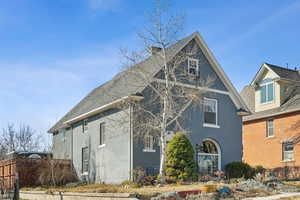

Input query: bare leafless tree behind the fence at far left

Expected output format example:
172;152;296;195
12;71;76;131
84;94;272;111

0;124;43;155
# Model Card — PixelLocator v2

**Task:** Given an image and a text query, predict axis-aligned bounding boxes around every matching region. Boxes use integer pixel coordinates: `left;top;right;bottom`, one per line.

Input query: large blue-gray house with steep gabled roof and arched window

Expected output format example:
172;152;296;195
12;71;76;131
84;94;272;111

49;32;248;183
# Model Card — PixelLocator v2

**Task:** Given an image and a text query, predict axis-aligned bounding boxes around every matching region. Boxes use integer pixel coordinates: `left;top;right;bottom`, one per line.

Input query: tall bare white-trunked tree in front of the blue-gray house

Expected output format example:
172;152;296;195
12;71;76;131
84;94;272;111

122;0;215;183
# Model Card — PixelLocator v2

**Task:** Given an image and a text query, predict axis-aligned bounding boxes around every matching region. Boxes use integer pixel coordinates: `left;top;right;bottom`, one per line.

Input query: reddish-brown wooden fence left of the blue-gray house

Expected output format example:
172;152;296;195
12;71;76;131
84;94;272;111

0;158;77;189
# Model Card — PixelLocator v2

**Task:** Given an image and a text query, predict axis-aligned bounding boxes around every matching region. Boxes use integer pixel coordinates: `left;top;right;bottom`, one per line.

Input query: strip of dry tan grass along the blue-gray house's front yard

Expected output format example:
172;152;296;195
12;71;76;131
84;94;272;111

21;184;216;195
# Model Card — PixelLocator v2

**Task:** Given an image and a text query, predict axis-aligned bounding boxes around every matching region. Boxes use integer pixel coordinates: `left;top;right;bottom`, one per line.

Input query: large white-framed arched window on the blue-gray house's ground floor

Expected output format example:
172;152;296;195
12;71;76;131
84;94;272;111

197;139;221;174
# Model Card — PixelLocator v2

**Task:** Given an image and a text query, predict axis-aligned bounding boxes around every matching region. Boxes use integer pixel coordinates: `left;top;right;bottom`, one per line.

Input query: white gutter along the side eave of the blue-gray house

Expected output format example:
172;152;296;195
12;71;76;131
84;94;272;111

64;96;144;125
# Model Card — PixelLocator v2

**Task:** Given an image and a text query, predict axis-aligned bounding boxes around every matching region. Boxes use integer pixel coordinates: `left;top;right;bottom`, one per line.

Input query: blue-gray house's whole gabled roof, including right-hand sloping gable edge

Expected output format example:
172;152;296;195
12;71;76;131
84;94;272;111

48;32;248;133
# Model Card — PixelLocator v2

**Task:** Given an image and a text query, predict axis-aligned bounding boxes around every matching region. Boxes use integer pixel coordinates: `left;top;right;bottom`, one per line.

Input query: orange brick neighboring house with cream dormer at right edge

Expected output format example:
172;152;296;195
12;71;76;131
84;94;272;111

241;63;300;168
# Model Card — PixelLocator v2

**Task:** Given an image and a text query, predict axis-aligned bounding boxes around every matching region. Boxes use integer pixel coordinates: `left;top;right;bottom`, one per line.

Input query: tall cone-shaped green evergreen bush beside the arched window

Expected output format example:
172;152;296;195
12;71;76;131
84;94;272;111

166;133;197;182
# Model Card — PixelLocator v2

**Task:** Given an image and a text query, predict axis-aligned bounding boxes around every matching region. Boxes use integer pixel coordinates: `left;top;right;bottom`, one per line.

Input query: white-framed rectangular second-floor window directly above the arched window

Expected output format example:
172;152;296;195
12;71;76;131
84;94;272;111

203;98;218;125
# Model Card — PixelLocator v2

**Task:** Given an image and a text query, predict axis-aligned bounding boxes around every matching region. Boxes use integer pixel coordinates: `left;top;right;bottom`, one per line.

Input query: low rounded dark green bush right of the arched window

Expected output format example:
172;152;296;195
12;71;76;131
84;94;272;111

225;162;255;179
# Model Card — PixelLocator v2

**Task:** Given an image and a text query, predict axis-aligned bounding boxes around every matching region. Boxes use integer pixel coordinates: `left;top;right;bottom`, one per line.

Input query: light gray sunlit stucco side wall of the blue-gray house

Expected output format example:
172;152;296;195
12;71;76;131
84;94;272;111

73;109;131;184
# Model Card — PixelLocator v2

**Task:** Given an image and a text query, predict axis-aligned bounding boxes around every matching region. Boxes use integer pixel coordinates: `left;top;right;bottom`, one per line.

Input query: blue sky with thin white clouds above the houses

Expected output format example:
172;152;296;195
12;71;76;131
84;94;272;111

0;0;300;137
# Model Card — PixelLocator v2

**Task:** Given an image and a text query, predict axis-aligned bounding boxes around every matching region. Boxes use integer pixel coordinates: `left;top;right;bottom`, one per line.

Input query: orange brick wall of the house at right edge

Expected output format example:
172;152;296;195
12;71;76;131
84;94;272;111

243;112;300;168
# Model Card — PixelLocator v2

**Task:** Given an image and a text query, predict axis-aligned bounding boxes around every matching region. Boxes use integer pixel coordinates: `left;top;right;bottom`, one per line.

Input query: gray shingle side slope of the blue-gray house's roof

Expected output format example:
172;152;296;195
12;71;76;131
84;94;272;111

48;32;198;133
